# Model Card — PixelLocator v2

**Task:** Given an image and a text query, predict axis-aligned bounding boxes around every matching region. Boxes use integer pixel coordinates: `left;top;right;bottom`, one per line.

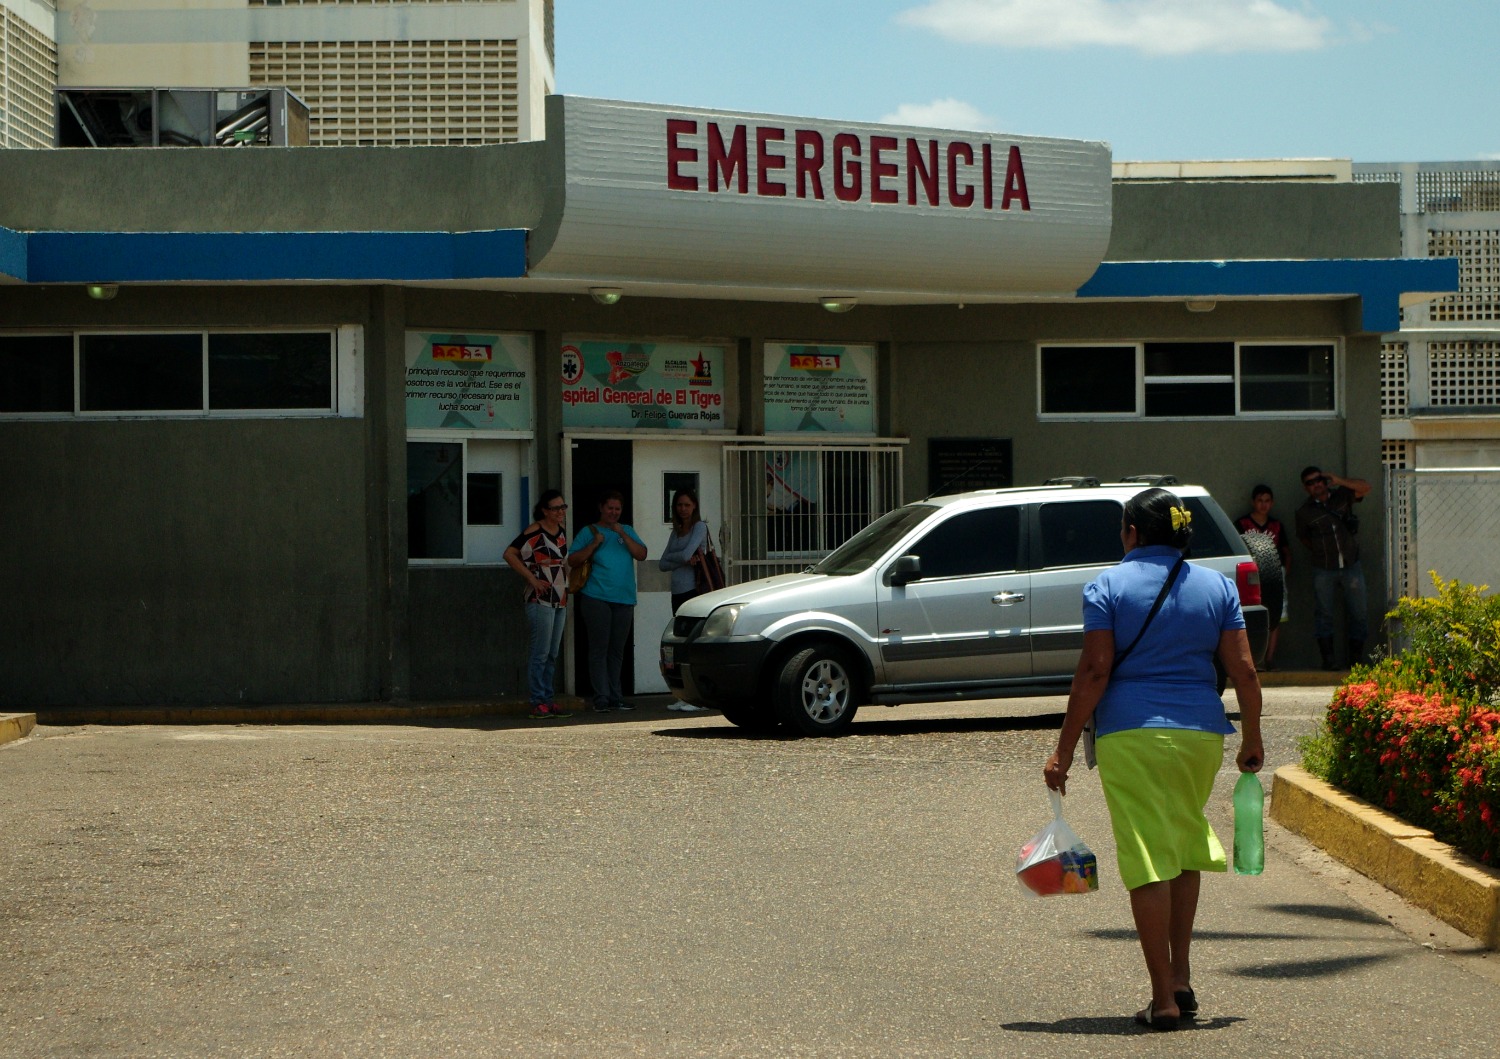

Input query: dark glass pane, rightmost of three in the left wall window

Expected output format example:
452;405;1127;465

209;332;333;410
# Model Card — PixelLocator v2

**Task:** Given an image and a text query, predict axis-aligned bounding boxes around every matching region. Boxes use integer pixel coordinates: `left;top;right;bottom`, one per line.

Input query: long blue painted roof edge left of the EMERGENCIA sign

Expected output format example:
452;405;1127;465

26;228;527;284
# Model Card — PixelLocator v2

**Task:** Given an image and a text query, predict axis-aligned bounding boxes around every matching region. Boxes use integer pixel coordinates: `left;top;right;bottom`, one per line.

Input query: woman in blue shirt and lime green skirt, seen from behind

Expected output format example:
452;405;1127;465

1043;489;1263;1031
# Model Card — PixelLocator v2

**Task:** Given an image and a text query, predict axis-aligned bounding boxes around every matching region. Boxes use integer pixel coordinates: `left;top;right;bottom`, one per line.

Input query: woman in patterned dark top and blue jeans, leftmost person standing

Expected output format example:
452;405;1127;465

506;489;573;720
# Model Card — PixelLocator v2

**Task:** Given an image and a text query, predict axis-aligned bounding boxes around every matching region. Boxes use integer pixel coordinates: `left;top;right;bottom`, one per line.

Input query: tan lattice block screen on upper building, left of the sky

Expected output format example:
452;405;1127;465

251;39;521;147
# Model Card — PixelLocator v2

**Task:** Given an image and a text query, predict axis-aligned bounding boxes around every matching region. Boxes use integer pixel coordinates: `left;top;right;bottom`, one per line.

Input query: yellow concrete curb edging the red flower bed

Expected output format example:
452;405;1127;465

1271;765;1500;950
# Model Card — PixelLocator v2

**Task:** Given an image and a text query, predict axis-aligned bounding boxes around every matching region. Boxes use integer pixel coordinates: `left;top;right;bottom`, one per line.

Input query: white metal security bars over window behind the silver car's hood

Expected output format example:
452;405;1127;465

719;441;906;584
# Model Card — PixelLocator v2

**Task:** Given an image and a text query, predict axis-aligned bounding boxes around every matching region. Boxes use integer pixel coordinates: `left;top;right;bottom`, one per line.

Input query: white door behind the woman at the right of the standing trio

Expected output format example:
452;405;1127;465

630;440;725;695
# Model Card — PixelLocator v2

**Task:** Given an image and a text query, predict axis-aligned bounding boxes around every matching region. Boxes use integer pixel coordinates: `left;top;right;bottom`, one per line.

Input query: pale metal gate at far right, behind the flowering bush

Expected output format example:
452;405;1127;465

1386;467;1500;605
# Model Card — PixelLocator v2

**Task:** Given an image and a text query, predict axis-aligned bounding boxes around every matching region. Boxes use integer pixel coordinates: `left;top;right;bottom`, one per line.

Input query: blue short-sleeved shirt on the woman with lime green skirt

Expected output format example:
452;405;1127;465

1083;545;1245;737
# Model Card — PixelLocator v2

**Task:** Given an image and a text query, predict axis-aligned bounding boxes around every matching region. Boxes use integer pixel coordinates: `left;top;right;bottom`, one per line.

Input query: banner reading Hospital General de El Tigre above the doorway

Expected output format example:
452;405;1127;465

561;339;728;431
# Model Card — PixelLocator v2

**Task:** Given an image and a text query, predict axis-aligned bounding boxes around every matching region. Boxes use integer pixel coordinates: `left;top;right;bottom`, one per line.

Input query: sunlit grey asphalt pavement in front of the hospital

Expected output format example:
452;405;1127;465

0;689;1500;1059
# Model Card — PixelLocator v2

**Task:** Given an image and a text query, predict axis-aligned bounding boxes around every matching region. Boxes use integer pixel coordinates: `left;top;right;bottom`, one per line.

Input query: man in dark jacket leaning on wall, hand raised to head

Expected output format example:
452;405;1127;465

1298;467;1370;669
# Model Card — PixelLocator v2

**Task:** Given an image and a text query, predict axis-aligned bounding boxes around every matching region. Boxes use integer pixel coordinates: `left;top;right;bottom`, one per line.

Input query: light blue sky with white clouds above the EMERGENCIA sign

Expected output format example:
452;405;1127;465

557;0;1500;162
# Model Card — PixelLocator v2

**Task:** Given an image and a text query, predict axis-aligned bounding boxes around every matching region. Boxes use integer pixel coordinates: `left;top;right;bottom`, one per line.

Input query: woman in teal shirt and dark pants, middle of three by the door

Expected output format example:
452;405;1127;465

567;491;647;714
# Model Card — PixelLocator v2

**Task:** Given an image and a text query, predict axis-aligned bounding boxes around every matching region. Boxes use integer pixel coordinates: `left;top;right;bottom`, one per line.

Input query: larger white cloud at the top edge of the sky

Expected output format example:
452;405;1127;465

897;0;1334;56
